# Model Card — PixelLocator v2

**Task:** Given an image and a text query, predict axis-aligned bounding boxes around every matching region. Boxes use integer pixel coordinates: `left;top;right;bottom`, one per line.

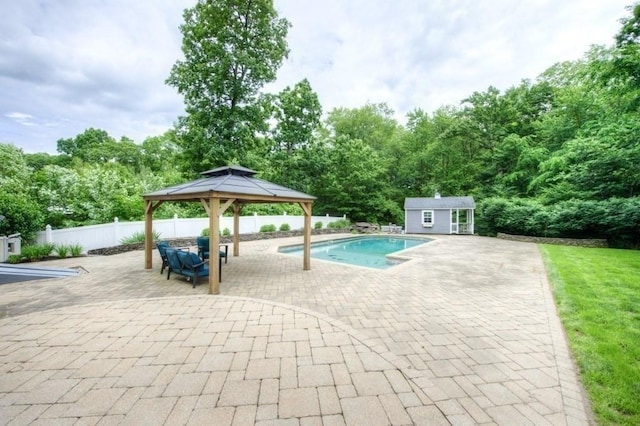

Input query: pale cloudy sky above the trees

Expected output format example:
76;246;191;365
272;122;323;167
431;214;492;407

0;0;632;154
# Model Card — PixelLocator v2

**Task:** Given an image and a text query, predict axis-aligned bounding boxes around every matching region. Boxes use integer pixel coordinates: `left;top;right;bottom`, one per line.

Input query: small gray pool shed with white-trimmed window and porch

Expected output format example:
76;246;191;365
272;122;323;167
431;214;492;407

404;192;476;234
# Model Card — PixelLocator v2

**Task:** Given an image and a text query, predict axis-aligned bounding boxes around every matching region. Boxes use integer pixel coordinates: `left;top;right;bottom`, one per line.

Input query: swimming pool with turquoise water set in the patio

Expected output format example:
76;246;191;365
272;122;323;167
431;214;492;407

278;236;431;269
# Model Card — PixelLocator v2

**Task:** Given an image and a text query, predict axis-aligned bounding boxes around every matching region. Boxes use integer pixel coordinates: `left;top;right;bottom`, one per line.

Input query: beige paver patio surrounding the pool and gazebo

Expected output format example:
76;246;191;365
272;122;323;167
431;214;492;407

0;236;591;425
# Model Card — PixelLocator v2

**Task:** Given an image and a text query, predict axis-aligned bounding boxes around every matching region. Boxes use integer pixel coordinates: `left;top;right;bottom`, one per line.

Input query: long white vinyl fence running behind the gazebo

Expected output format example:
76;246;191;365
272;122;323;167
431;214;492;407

37;214;345;252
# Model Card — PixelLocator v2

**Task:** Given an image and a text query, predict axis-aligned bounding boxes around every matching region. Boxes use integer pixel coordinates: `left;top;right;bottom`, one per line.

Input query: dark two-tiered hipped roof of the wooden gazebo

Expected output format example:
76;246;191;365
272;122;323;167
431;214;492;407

143;166;316;203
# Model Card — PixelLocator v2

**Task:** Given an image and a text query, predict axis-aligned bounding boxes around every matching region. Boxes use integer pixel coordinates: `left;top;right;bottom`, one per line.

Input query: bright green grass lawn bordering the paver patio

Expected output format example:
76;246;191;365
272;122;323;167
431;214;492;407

540;245;640;425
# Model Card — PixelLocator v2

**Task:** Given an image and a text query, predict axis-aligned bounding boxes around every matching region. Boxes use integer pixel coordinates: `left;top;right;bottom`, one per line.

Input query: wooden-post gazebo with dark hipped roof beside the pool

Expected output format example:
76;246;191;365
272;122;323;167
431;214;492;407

143;166;316;294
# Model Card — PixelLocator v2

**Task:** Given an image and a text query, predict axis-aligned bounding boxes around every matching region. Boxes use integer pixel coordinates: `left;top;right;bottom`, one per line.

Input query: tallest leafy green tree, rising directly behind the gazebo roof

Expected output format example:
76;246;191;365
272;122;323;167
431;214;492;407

167;0;289;172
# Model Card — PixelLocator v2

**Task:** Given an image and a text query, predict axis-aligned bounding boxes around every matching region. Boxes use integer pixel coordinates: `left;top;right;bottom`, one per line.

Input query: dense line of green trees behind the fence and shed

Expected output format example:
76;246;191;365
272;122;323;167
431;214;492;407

0;0;640;247
